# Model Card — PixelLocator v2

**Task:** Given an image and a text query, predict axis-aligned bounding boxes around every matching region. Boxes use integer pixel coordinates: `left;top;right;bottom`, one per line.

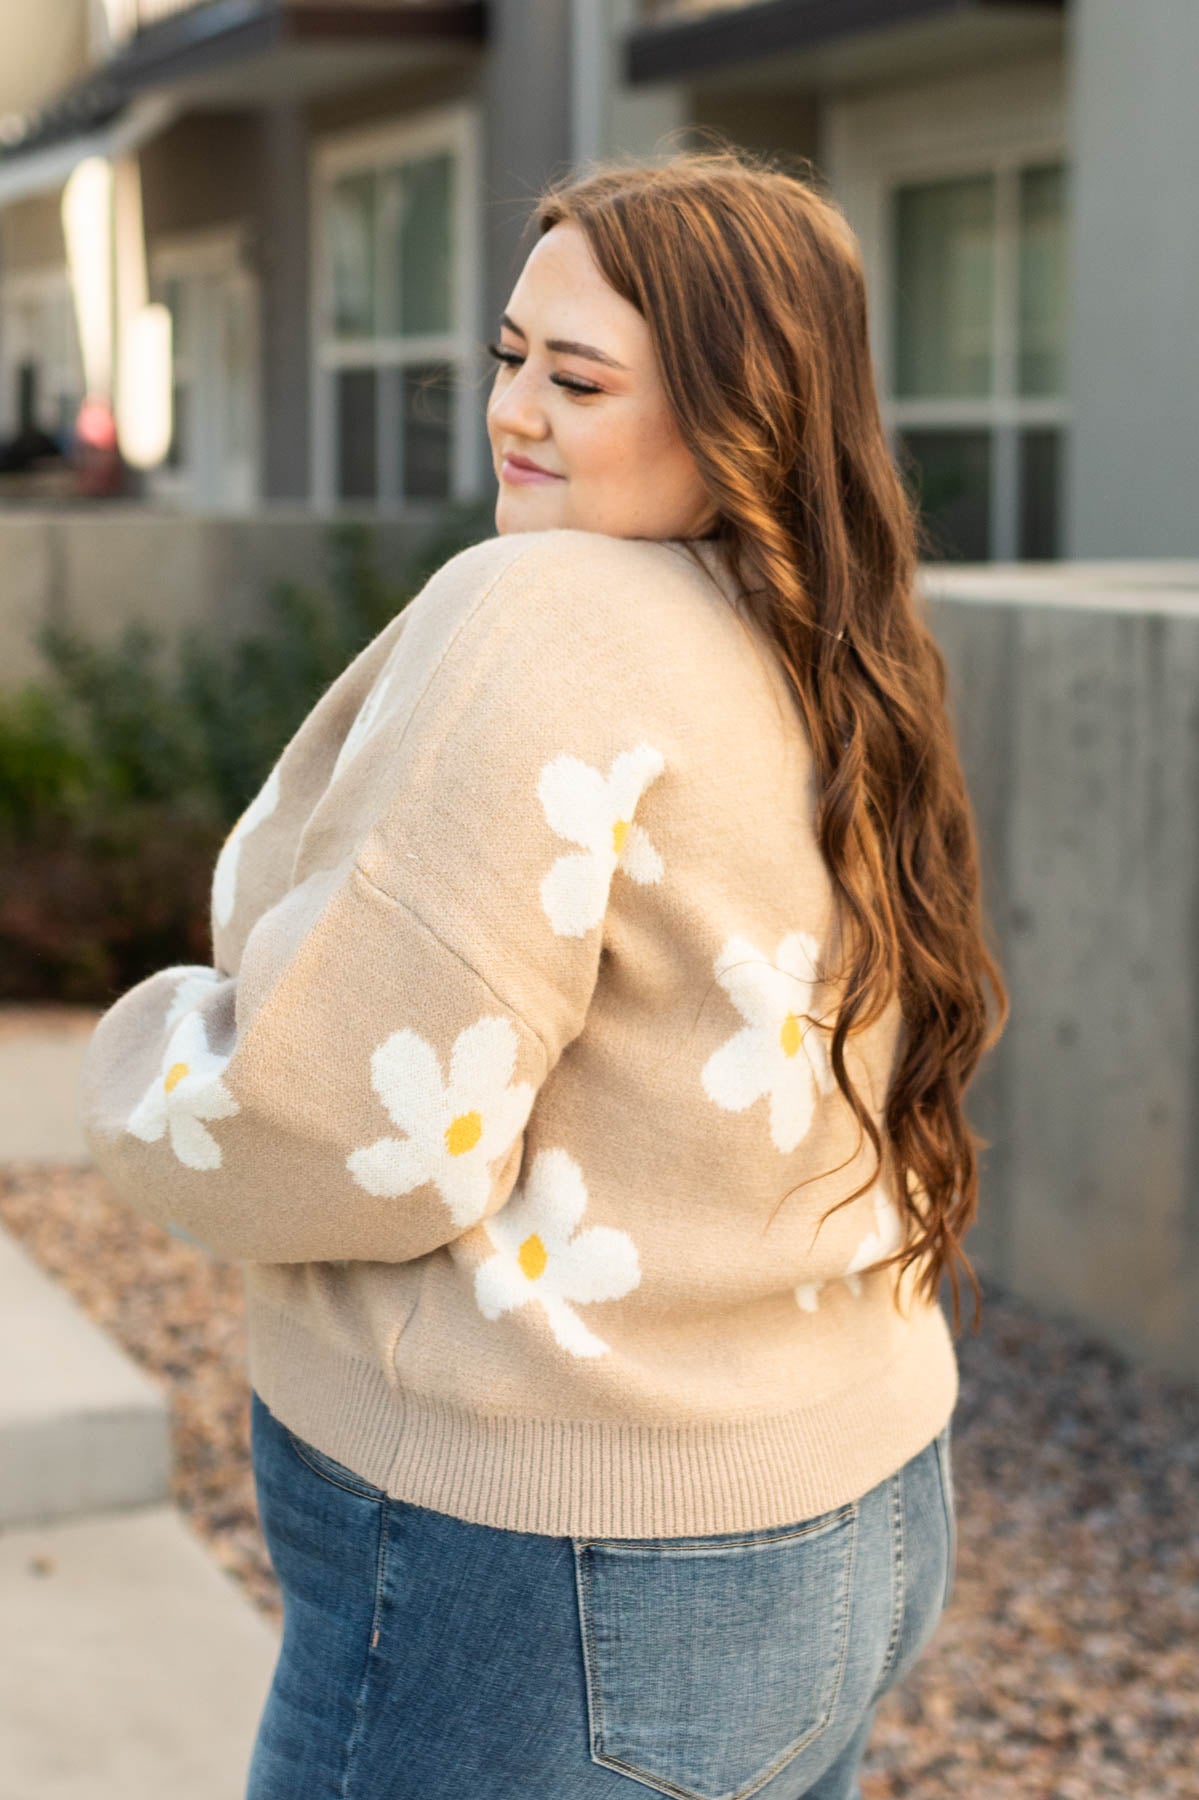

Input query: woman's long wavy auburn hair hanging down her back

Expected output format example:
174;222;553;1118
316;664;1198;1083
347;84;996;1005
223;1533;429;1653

529;140;1008;1332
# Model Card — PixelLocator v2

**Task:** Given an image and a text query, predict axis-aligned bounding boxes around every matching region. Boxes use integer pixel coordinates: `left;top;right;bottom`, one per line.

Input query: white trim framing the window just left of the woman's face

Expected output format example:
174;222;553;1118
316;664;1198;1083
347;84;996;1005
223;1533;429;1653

310;103;482;513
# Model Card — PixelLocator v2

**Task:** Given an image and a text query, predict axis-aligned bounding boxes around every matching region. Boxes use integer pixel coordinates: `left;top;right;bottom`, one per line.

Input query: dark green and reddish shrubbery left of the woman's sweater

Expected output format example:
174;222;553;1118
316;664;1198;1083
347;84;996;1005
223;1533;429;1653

0;506;491;1006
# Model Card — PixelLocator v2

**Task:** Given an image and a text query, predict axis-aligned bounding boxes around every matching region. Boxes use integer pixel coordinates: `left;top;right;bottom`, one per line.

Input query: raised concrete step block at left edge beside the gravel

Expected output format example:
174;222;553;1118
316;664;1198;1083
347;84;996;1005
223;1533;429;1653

0;1229;171;1526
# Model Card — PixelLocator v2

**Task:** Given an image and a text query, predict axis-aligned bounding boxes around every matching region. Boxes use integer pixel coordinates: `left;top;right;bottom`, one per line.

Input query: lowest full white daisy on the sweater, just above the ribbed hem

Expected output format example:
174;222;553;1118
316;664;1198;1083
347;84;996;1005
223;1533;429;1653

475;1148;641;1355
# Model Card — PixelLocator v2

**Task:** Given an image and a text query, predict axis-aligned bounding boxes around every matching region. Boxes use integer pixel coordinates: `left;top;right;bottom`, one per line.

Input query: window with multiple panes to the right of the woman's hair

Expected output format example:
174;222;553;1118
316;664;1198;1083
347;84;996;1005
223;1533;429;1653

886;160;1068;562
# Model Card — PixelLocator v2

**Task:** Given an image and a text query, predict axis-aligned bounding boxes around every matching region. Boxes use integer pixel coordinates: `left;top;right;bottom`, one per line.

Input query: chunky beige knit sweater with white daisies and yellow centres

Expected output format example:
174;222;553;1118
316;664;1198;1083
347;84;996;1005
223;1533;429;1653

79;529;958;1535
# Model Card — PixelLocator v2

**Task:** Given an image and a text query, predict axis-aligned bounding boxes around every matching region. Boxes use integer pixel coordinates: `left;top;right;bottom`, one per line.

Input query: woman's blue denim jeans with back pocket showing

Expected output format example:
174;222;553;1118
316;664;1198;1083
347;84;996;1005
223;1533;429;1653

247;1391;956;1800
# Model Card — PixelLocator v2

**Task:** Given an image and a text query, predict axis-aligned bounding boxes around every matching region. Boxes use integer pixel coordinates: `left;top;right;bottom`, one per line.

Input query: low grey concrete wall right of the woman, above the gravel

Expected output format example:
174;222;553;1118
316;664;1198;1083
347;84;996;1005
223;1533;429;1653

925;565;1199;1377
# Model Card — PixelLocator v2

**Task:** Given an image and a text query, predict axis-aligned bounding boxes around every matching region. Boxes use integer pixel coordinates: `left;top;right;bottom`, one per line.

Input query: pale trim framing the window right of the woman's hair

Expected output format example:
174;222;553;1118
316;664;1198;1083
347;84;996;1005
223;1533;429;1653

821;56;1071;562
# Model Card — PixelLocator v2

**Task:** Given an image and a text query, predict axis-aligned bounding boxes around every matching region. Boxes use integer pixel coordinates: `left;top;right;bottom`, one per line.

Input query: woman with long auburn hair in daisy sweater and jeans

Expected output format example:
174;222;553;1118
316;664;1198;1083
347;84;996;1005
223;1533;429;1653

83;151;1006;1800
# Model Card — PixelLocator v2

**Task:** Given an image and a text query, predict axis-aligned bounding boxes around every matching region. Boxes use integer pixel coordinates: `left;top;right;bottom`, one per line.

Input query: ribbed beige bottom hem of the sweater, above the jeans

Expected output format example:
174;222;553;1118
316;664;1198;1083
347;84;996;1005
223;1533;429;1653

247;1292;958;1537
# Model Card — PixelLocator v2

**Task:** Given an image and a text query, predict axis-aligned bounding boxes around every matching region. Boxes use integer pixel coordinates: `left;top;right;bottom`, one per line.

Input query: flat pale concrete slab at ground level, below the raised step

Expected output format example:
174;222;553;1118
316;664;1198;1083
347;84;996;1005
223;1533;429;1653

0;1507;279;1800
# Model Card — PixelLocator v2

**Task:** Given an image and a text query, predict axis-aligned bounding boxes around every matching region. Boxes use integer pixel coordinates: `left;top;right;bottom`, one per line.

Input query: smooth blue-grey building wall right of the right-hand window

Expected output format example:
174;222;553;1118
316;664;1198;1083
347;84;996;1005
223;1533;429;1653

1066;0;1199;556
